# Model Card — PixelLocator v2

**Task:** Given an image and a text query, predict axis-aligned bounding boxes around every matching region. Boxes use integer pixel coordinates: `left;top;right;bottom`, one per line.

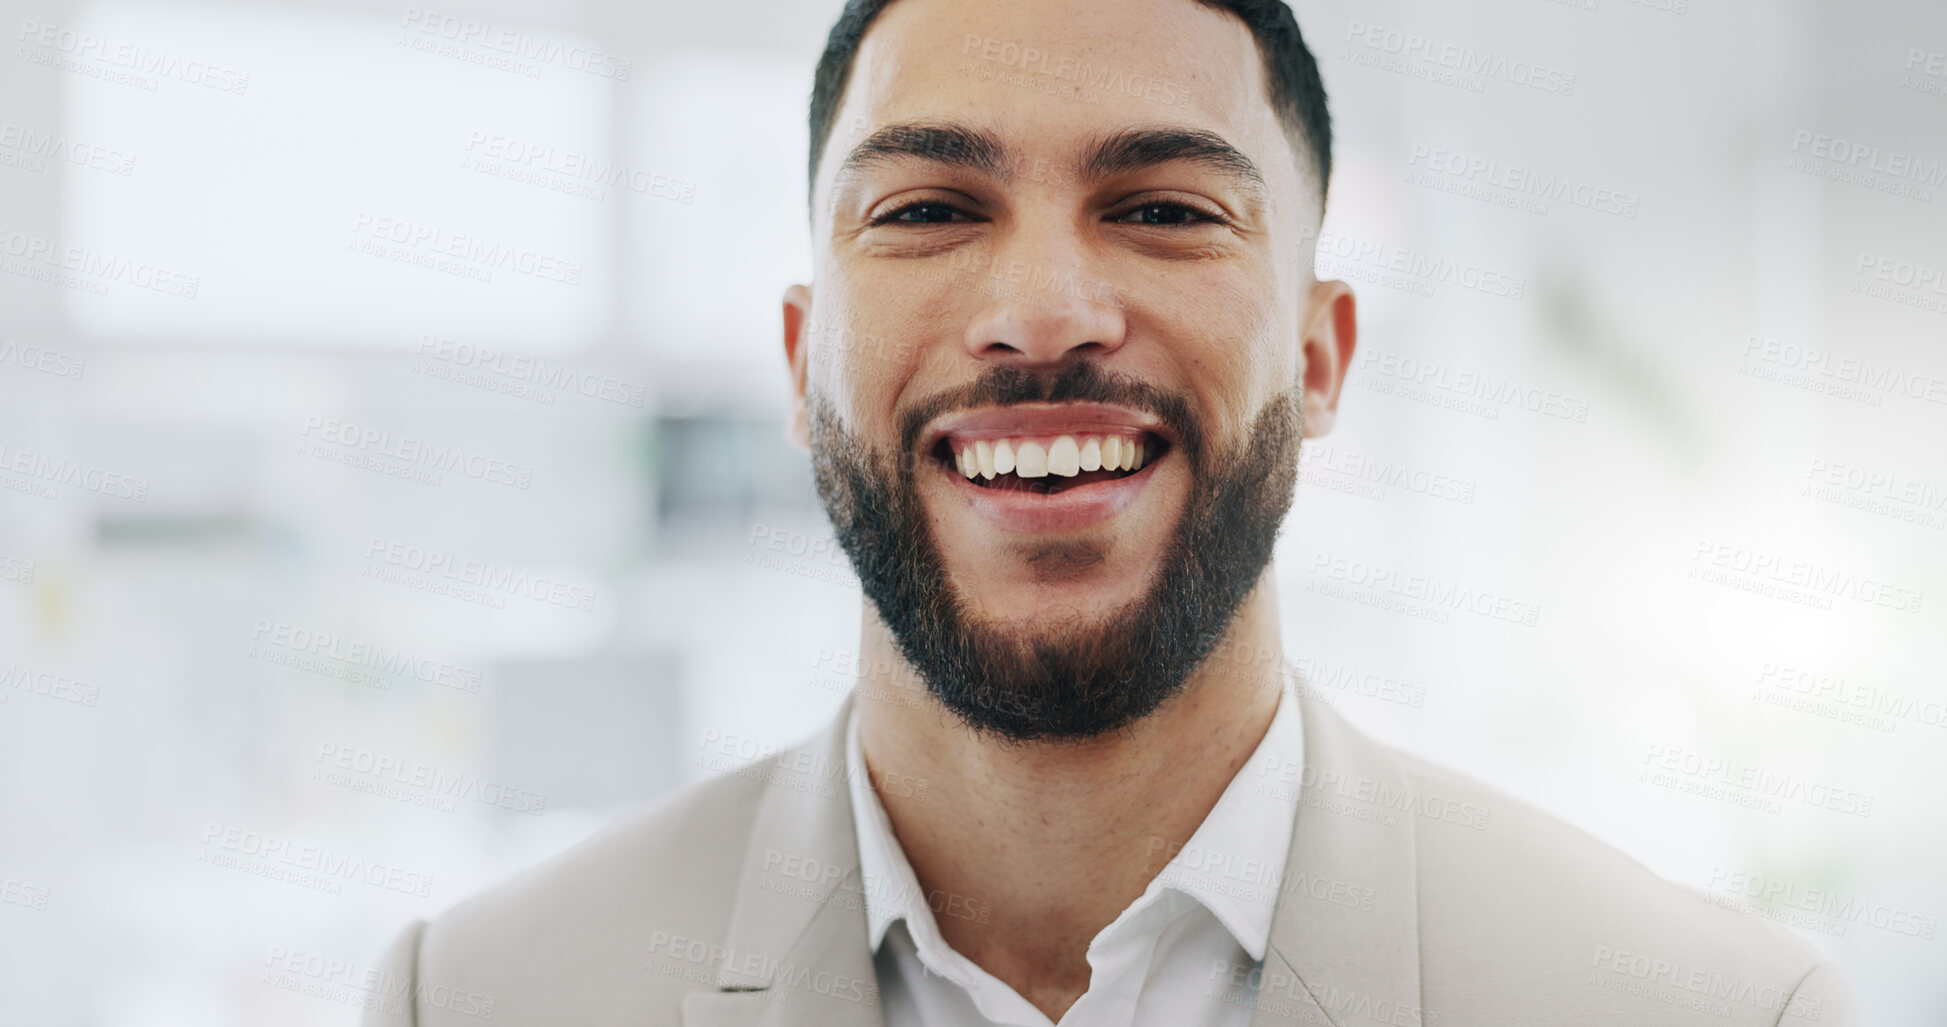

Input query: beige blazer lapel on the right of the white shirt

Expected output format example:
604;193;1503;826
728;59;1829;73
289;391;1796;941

1250;670;1425;1027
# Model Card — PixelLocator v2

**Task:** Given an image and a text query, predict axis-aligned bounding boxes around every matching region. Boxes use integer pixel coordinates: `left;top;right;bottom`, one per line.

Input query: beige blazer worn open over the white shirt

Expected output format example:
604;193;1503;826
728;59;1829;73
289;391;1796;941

364;700;1854;1027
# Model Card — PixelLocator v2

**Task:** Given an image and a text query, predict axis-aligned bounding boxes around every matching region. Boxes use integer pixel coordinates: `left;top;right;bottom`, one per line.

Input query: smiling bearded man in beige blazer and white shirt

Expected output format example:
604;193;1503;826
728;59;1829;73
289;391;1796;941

372;0;1850;1027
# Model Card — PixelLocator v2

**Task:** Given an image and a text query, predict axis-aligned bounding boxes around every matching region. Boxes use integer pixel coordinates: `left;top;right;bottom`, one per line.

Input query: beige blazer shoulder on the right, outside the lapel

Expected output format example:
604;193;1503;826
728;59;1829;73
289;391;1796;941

1394;752;1850;1025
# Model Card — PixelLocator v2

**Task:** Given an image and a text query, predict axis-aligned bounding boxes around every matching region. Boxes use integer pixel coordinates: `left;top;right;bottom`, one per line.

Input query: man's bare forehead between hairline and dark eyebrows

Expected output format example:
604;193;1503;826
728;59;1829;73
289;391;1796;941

820;0;1301;197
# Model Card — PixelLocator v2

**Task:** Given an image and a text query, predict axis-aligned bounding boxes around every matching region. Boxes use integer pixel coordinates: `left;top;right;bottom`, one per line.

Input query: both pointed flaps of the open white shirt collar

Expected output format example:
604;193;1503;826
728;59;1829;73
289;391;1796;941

845;668;1304;959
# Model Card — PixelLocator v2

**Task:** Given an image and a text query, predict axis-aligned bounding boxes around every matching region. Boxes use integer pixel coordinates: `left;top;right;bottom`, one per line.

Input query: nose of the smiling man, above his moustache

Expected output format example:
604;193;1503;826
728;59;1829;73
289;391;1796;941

966;246;1127;366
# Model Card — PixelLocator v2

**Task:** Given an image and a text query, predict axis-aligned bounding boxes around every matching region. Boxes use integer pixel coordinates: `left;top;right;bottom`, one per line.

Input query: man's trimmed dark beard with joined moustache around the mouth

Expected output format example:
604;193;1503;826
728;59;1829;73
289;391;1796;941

810;361;1304;742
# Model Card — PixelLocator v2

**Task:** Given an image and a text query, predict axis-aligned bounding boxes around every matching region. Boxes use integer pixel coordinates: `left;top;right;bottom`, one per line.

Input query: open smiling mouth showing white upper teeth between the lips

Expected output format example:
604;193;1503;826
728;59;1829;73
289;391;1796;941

933;431;1170;495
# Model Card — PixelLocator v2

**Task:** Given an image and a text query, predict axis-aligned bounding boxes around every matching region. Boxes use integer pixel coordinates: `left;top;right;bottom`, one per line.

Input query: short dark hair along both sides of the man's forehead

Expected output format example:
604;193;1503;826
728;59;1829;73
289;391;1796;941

808;0;1332;205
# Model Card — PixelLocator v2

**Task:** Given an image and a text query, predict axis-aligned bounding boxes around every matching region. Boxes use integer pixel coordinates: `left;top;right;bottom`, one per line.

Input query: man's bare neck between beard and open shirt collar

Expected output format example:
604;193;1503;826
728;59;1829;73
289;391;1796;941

857;569;1283;1019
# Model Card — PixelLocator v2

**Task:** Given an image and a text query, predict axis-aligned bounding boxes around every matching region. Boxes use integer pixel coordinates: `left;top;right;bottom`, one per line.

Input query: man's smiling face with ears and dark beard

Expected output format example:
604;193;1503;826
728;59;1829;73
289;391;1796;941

787;0;1351;739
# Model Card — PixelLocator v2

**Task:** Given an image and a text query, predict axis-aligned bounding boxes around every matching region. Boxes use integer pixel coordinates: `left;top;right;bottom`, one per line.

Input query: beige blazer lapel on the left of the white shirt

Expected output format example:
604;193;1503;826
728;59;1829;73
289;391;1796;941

683;696;884;1027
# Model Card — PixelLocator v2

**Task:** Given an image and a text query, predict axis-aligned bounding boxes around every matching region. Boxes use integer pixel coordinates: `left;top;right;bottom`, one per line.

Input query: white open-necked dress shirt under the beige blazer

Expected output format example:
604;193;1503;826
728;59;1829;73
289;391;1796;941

845;674;1304;1027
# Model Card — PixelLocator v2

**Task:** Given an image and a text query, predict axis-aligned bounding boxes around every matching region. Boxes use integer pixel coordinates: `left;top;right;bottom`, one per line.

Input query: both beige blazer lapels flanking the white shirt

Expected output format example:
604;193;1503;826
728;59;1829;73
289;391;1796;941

683;678;1425;1027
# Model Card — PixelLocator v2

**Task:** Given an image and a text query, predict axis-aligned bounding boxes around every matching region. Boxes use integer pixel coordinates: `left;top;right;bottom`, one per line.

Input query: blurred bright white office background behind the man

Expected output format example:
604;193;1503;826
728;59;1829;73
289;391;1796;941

0;0;1947;1027
